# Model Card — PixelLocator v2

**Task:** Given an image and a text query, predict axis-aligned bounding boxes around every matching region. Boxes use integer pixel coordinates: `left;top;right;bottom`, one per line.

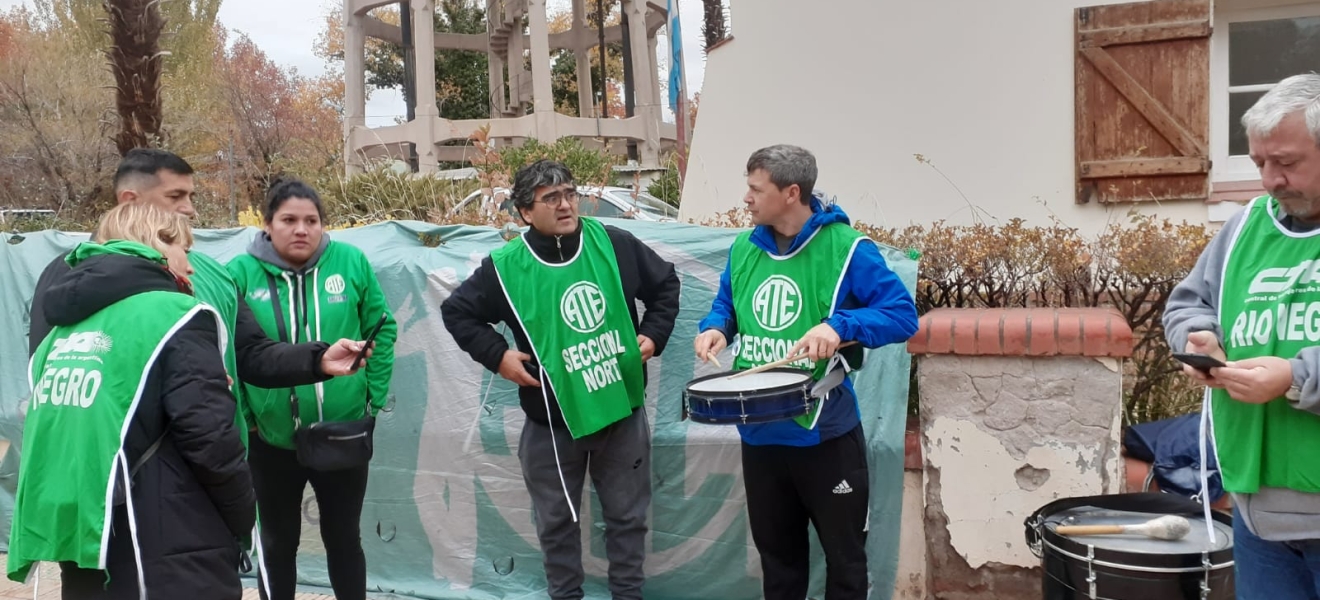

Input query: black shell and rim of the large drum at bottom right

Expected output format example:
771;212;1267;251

1027;493;1236;600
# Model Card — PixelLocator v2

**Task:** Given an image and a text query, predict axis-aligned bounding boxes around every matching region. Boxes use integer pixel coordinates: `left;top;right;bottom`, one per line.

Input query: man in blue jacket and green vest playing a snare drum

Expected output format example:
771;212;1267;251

694;145;917;600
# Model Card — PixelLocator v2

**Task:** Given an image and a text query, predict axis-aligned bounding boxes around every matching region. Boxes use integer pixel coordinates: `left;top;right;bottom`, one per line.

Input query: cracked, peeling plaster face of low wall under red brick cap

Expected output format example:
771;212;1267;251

917;355;1122;572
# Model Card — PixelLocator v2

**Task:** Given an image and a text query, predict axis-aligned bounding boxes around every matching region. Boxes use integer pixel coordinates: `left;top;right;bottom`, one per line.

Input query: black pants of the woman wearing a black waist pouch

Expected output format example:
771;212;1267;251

248;435;368;600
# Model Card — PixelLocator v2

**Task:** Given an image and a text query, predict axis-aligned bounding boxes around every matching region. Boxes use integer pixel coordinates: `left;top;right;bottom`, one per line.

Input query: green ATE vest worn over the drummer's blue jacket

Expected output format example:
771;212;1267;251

729;224;866;429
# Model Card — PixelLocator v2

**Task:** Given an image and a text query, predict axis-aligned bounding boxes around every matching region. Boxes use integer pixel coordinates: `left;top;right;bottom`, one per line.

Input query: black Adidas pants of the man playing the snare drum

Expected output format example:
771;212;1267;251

742;425;870;600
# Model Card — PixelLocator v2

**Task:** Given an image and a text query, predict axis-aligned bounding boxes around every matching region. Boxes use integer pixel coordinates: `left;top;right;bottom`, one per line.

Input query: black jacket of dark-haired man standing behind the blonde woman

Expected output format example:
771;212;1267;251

28;255;330;389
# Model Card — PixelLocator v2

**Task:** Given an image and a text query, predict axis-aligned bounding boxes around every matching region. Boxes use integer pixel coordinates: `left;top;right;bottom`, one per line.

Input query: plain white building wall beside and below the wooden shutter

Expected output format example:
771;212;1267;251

681;0;1208;235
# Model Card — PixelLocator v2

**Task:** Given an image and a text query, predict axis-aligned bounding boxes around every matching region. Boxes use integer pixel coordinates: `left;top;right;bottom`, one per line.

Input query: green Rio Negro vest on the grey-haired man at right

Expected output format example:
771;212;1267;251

1210;196;1320;493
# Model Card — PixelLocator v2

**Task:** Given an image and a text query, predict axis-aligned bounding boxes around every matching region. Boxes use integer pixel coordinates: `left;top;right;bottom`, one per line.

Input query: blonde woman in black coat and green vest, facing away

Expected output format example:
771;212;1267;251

8;203;256;600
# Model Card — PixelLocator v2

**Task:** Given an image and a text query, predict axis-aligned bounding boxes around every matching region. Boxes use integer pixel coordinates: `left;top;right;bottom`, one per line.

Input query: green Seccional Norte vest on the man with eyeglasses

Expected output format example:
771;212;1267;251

491;218;645;438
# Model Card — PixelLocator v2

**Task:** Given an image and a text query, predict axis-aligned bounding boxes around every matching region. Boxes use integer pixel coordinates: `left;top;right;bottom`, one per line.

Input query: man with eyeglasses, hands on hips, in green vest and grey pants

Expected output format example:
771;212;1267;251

441;160;680;600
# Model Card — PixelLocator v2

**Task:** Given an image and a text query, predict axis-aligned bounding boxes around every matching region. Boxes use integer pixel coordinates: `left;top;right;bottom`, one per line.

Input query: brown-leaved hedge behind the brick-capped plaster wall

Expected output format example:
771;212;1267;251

704;210;1212;423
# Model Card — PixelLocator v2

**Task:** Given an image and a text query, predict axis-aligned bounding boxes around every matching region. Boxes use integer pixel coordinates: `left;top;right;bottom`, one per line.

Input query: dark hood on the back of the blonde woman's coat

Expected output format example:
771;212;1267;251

41;240;178;326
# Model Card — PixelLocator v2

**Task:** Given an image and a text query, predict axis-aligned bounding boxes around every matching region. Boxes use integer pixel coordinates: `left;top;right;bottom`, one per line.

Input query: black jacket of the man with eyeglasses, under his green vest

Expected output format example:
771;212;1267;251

441;224;681;427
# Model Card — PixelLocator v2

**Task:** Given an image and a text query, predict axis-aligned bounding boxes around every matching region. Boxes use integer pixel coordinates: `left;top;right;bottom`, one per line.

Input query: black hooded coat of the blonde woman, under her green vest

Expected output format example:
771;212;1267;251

44;255;256;599
